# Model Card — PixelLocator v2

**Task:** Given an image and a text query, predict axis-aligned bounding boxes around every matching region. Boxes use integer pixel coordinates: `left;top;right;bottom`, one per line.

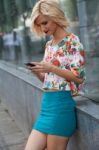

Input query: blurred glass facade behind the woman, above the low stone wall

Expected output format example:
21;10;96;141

0;0;99;93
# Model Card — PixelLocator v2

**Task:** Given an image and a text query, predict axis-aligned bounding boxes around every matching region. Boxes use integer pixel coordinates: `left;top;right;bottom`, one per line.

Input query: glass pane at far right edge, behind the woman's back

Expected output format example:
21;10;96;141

86;0;99;95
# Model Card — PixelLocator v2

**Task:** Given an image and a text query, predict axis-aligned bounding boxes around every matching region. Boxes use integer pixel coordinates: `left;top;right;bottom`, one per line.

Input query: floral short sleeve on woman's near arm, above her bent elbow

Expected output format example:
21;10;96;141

67;35;85;79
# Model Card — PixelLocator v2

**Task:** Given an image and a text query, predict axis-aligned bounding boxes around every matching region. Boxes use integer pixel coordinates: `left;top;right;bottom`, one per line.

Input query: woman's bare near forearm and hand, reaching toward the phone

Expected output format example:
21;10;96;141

29;62;83;84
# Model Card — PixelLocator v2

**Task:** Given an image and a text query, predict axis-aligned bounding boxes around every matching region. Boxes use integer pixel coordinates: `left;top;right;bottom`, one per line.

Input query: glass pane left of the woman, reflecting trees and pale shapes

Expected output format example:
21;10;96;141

0;0;45;65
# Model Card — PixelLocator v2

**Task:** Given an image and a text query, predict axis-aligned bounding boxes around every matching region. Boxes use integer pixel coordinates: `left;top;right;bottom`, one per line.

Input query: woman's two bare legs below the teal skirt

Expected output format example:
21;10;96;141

25;130;69;150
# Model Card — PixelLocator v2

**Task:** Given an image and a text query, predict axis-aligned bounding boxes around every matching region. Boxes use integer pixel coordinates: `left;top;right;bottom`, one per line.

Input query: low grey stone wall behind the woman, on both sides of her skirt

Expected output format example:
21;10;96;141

0;63;99;150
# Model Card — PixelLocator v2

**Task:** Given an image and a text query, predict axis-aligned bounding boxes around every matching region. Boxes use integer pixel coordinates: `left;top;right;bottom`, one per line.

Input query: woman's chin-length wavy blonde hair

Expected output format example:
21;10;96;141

31;0;68;36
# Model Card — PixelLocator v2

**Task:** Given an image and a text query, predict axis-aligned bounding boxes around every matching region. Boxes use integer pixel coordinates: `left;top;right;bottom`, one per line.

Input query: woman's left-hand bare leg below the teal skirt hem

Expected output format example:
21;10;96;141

25;130;47;150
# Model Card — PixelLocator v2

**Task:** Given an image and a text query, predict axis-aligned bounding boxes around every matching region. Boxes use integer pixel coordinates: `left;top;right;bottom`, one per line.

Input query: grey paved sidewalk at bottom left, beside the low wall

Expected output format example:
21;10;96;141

0;101;27;150
